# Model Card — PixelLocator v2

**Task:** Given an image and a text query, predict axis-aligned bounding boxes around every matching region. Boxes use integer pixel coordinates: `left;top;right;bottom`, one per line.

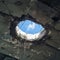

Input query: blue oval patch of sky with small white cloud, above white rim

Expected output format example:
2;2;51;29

18;20;44;34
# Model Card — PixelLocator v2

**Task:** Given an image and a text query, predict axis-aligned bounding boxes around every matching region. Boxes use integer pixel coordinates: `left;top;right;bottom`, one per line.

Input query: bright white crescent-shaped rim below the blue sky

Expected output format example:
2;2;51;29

16;26;46;41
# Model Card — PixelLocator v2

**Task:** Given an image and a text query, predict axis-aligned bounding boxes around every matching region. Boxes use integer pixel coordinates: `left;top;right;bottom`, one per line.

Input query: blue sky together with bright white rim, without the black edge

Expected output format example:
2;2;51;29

16;20;46;41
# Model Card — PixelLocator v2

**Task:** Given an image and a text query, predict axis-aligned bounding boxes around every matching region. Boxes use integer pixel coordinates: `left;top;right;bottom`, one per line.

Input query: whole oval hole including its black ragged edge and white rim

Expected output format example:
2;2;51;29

10;15;46;41
